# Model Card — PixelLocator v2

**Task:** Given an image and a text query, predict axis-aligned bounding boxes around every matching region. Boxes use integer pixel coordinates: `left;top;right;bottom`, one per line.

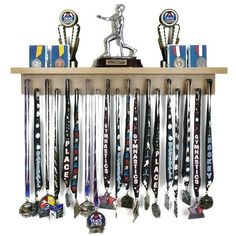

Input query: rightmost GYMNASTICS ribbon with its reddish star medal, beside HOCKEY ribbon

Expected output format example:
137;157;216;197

188;89;204;219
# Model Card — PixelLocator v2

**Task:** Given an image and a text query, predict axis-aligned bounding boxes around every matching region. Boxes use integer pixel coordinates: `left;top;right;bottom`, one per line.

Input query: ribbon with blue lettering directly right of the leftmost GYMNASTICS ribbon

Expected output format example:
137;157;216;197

115;89;122;198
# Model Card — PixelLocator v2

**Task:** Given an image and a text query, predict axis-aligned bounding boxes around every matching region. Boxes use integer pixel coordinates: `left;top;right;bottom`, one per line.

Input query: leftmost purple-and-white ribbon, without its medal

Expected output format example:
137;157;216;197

24;80;30;199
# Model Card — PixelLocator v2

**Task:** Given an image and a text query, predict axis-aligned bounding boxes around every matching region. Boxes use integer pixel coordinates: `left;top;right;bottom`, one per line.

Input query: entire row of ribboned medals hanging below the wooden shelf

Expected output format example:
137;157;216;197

19;79;214;232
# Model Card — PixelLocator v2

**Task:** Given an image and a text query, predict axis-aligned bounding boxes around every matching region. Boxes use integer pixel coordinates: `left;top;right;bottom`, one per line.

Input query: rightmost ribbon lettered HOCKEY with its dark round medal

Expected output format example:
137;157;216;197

200;79;214;210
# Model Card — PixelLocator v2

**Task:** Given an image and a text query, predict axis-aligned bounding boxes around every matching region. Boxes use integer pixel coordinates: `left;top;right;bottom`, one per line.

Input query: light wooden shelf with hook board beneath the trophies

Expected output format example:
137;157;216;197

11;67;227;94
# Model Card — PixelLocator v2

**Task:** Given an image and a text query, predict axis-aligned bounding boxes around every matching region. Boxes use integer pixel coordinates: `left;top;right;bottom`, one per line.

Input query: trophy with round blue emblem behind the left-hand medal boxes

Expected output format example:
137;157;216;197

58;9;80;67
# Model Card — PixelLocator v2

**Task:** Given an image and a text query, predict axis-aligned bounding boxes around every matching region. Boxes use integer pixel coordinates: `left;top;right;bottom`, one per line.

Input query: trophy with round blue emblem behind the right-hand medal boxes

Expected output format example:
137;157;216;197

157;9;180;67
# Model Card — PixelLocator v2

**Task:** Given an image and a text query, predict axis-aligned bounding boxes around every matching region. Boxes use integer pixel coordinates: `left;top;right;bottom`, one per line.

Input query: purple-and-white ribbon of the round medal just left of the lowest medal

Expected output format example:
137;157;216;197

85;80;91;199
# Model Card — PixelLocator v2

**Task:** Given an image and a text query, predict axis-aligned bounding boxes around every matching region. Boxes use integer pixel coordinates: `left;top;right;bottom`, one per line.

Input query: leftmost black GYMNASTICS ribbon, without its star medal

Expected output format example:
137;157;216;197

103;79;111;190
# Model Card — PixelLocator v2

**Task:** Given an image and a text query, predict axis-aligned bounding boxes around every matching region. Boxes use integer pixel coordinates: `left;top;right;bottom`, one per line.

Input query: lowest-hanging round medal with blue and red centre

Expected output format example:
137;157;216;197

87;211;106;233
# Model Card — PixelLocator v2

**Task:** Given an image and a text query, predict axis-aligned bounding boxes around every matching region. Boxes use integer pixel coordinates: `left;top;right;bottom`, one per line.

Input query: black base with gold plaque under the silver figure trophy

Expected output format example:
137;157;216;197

94;57;143;67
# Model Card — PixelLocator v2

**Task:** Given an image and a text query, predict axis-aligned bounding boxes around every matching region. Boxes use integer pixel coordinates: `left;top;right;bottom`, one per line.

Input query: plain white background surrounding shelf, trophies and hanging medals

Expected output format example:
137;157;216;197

0;0;236;235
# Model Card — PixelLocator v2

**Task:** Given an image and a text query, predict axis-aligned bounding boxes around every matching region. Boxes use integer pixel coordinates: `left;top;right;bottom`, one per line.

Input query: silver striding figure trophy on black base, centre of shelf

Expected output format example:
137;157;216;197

95;4;142;67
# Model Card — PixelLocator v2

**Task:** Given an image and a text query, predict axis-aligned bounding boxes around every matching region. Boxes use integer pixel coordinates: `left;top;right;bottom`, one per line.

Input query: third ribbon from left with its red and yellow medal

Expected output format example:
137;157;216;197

39;79;56;217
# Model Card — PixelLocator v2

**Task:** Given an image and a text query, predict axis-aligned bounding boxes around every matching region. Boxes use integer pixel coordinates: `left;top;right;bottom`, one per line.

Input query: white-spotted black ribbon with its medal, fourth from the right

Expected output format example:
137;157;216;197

173;89;180;217
